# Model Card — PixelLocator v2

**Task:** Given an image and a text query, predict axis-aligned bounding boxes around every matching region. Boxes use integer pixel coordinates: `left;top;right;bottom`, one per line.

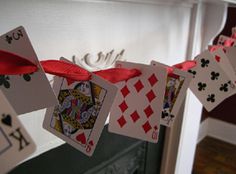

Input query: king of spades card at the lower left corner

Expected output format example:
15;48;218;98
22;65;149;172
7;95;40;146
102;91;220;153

0;90;36;173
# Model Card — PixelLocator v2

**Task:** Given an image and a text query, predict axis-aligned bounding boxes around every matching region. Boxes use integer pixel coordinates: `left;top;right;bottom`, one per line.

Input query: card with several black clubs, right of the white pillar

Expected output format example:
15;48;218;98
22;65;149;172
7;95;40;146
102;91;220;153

189;51;235;111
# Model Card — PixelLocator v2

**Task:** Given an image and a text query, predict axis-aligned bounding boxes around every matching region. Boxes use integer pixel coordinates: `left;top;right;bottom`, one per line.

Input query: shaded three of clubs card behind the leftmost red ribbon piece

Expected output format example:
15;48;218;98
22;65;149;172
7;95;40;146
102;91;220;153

0;27;57;115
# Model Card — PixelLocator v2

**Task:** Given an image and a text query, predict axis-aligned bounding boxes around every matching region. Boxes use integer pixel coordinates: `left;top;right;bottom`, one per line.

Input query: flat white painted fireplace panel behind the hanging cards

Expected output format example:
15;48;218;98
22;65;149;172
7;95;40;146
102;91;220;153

0;0;191;158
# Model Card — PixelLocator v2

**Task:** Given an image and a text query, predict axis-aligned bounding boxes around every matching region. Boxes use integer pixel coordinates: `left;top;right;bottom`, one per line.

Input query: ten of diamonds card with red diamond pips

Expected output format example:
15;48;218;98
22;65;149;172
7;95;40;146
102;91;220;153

109;61;167;143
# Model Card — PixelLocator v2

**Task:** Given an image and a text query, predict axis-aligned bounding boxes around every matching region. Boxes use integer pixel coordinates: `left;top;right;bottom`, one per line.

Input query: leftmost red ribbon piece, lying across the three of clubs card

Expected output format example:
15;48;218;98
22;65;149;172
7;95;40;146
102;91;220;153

0;50;38;75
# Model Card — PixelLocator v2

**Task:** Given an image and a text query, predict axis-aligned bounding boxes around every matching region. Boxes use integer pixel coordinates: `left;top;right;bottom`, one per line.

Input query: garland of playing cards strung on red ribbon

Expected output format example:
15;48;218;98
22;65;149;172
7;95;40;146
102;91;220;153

0;27;236;161
